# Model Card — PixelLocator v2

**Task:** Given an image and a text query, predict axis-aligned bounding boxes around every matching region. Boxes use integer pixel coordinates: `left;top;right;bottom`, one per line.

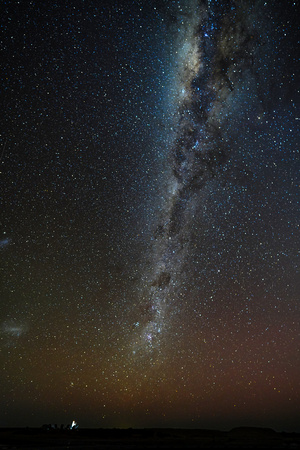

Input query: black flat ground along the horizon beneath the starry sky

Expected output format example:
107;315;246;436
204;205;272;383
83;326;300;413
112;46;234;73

0;428;300;450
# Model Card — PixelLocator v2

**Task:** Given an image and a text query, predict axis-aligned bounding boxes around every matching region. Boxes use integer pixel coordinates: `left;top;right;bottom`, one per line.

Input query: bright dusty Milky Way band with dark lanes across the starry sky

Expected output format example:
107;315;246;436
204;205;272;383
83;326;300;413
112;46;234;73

134;1;259;353
